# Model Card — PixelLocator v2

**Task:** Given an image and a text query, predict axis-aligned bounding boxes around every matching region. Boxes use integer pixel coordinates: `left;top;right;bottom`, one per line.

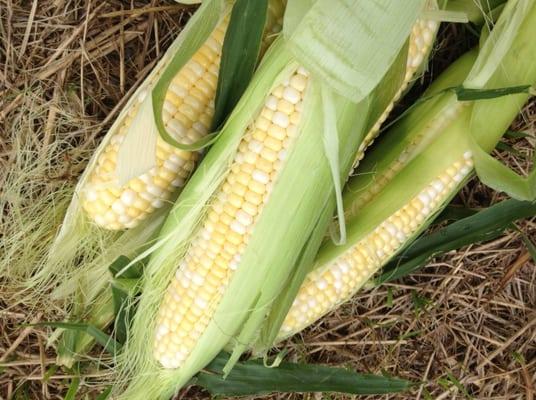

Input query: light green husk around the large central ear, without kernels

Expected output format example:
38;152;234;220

117;0;423;400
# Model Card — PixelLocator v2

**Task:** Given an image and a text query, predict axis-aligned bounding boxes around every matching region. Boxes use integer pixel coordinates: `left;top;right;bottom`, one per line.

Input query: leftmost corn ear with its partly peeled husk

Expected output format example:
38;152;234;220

29;1;229;303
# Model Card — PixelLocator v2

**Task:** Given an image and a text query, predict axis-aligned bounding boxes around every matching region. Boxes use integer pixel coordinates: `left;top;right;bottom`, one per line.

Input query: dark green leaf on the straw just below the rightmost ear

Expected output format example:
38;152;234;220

374;199;536;285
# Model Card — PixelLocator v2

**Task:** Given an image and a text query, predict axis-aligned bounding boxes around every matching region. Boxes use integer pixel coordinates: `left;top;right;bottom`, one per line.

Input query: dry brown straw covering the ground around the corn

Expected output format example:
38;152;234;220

0;0;536;400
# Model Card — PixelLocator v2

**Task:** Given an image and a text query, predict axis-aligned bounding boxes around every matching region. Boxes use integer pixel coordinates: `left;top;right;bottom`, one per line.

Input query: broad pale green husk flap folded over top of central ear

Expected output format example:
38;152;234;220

283;0;424;102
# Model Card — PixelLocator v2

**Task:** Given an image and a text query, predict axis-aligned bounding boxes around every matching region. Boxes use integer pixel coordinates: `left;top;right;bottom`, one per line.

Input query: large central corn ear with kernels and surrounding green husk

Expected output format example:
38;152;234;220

118;2;426;399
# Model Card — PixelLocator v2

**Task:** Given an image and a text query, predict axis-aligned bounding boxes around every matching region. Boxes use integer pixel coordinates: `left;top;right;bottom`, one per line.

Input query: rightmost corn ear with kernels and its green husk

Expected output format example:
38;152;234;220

266;0;536;340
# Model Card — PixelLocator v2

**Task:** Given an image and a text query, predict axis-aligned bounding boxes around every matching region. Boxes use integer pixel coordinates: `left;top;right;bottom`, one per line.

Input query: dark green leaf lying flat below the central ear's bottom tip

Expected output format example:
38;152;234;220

194;354;411;396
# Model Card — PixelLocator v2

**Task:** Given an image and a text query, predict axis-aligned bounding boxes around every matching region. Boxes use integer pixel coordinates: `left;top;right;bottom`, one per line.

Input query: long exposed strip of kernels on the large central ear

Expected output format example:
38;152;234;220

154;68;308;368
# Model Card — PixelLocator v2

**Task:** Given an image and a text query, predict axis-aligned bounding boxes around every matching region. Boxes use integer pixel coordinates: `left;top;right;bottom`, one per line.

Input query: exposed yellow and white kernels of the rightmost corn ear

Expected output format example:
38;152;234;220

279;151;473;339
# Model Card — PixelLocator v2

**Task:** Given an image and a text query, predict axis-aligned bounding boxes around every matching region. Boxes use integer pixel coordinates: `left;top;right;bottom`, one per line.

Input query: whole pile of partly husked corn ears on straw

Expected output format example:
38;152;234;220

26;0;536;399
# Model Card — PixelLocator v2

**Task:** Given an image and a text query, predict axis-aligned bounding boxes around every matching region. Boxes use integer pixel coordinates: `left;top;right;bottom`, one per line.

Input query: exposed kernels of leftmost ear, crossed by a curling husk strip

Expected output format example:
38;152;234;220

82;20;229;230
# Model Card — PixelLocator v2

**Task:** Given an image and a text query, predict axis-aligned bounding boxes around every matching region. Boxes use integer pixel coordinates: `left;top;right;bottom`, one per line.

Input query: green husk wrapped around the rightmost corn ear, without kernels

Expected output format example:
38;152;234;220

256;0;536;351
